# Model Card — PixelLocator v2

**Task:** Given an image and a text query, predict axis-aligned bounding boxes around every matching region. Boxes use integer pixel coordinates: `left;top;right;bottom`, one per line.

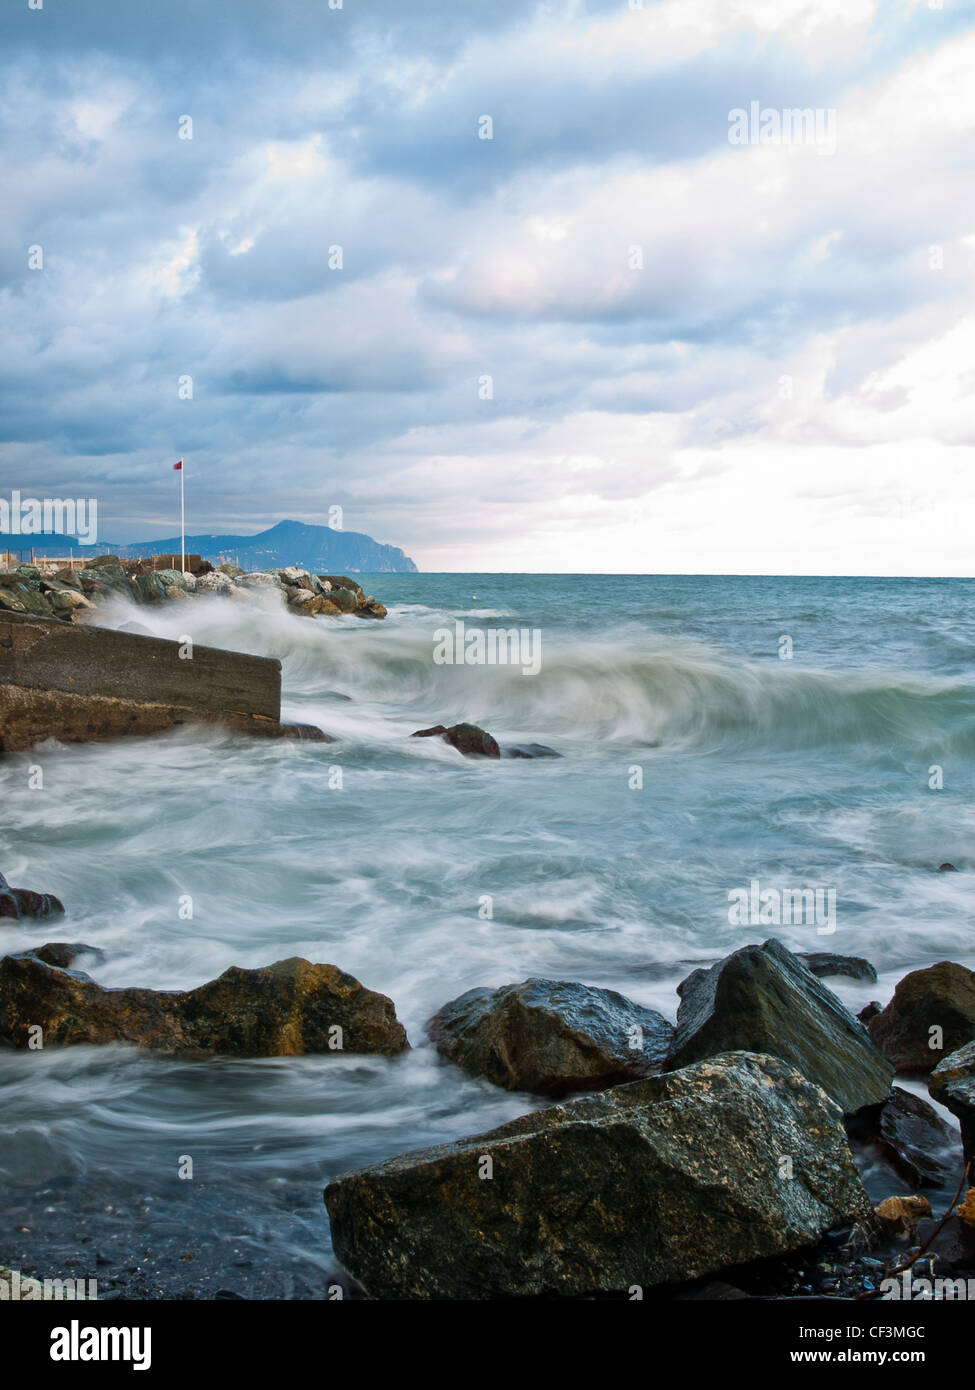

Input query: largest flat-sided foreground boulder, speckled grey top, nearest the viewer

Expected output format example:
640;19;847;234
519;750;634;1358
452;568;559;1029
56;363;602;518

325;1054;871;1298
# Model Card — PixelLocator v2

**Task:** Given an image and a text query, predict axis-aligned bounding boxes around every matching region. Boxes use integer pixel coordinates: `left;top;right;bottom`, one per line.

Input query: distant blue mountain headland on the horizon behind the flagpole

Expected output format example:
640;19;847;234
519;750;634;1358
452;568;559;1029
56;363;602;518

0;521;417;574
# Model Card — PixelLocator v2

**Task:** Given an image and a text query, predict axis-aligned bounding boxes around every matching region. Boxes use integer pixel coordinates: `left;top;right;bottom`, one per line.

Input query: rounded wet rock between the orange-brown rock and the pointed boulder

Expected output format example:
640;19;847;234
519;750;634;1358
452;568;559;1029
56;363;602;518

427;980;673;1095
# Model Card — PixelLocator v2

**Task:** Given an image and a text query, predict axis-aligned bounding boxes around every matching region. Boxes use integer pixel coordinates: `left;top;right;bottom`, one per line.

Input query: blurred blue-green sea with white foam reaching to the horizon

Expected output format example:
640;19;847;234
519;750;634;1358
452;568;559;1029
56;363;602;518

0;574;975;1298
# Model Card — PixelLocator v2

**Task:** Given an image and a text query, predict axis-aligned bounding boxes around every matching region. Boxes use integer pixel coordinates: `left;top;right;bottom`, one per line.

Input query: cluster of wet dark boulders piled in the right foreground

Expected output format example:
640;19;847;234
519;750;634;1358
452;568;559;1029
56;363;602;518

325;940;975;1298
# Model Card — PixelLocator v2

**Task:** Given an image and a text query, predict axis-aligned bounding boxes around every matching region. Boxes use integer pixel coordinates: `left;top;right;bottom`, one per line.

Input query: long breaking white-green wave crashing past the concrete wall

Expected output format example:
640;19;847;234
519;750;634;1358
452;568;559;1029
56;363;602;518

89;596;975;760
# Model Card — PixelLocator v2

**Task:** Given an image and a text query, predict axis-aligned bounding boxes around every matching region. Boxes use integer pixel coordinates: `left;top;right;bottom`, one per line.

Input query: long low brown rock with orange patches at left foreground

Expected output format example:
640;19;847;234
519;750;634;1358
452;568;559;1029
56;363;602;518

0;952;409;1056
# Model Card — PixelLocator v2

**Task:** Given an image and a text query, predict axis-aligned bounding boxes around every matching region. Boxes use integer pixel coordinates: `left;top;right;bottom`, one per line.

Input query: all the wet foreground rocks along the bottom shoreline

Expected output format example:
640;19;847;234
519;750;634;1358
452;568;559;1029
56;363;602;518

0;881;975;1300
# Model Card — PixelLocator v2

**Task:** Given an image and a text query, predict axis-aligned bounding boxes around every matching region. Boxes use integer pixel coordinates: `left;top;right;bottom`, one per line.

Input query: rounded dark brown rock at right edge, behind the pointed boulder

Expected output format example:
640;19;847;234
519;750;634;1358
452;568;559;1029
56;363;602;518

868;960;975;1072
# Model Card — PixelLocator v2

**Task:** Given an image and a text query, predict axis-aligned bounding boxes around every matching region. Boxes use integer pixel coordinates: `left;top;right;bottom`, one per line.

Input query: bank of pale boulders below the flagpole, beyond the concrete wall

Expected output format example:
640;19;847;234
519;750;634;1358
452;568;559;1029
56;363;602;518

0;555;387;623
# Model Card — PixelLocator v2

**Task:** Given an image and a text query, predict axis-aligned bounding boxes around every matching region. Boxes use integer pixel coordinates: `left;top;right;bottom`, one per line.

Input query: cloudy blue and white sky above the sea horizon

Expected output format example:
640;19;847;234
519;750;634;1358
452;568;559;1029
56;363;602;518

0;0;975;575
